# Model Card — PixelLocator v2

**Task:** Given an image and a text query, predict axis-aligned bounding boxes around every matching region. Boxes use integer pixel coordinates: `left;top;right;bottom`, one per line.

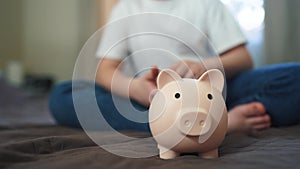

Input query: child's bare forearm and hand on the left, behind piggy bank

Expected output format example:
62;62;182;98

96;58;158;106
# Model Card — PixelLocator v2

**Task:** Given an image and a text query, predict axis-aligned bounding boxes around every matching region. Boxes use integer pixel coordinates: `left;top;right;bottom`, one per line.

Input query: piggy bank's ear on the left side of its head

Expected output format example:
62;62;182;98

157;69;182;89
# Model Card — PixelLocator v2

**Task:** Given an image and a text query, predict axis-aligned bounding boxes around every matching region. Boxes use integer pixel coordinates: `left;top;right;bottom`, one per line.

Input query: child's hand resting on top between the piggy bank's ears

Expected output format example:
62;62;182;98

170;60;205;79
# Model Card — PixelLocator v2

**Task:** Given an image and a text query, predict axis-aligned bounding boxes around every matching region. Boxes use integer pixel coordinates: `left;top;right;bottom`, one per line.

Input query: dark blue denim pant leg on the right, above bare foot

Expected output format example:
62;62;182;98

226;63;300;126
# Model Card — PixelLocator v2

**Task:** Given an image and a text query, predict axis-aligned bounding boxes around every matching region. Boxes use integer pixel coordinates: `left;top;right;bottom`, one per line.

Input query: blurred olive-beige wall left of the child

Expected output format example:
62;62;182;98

0;0;102;81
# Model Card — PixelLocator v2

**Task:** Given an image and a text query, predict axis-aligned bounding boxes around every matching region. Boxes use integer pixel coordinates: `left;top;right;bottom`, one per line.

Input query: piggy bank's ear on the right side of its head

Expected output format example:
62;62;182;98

198;69;225;92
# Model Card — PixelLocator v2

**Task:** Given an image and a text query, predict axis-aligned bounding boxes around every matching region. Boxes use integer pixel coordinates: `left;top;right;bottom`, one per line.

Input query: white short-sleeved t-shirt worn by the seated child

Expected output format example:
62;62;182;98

96;0;247;75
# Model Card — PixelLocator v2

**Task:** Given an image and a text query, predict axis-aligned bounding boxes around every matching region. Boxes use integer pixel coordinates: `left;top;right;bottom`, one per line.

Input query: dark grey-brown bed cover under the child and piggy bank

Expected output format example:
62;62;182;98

0;80;300;169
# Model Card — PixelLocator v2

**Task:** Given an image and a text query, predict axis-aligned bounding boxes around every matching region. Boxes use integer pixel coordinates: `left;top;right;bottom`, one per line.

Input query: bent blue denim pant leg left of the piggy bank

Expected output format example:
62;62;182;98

49;81;150;132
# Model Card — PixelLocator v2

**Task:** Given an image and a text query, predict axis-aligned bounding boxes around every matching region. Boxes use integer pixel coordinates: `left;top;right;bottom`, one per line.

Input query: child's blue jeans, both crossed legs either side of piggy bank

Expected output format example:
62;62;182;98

49;63;300;132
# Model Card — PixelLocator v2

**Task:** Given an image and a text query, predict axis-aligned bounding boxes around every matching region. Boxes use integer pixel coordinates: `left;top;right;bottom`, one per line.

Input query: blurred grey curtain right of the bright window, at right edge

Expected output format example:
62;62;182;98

264;0;300;64
